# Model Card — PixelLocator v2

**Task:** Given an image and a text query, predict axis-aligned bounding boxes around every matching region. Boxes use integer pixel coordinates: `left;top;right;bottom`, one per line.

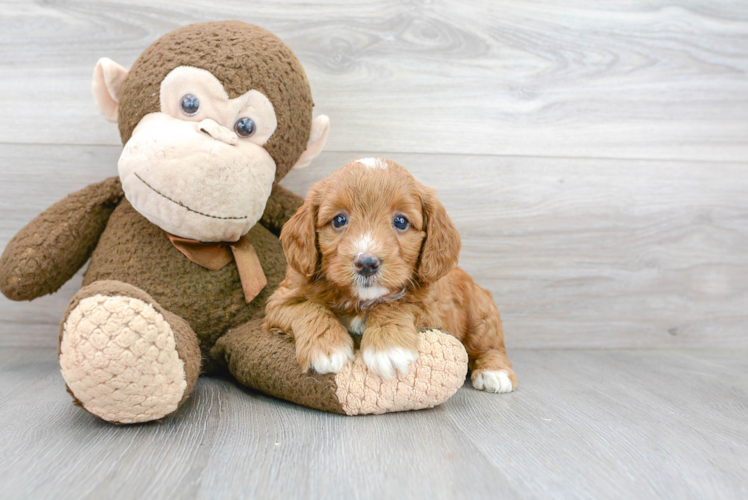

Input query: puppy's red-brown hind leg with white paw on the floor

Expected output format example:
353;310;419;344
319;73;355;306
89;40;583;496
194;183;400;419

463;286;517;393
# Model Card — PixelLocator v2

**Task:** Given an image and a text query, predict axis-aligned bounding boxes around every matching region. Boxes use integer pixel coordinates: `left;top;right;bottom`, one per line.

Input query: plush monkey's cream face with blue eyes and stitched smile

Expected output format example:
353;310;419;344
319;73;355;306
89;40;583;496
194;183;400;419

118;66;277;242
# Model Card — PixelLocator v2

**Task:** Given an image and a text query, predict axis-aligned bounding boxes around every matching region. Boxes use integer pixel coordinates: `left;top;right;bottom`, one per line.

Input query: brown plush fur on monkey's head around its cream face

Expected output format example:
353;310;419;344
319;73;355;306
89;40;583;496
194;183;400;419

119;21;314;182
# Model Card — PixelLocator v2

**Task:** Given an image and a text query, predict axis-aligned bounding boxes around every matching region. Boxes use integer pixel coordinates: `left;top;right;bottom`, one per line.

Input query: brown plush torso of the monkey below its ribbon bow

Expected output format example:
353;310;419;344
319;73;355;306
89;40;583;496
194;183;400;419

83;199;286;357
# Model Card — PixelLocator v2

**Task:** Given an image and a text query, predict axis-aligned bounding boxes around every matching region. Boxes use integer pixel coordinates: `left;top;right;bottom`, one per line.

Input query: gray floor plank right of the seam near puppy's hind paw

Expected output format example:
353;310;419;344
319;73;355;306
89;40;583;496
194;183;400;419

448;351;748;499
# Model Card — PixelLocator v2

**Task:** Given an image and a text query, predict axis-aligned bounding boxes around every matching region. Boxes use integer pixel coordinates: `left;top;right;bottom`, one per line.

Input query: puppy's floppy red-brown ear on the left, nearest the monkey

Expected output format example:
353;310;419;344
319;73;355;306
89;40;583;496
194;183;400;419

280;185;318;278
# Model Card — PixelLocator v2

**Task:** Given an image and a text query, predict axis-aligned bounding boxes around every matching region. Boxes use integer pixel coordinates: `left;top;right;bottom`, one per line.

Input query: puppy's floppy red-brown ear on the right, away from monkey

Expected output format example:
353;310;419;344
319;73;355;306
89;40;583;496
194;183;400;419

418;187;461;283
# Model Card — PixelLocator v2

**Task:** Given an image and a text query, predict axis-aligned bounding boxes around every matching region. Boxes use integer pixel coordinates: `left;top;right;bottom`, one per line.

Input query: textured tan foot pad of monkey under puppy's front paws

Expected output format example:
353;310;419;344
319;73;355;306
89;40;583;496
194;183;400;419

335;330;468;415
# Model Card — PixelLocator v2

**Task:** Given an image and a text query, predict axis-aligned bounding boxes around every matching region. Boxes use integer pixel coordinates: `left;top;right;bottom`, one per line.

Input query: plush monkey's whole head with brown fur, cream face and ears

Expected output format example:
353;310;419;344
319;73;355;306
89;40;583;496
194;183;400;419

91;21;330;242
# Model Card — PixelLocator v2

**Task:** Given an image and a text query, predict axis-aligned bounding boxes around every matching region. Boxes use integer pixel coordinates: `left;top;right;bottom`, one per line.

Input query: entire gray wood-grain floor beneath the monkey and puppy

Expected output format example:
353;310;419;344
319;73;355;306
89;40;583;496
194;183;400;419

0;348;748;499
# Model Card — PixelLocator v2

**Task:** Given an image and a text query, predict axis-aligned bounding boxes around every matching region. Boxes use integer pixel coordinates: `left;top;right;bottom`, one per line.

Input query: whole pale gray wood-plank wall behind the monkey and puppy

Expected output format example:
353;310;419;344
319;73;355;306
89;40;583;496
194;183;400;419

0;0;748;348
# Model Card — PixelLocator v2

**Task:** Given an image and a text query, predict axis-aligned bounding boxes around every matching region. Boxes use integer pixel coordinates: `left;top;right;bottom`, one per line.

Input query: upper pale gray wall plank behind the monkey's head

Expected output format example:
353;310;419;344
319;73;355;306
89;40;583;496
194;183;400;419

0;0;748;161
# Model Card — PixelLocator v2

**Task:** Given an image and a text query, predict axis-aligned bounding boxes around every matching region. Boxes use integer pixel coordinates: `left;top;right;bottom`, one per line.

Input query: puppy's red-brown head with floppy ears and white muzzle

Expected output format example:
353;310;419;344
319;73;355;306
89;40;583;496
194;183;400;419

281;158;460;301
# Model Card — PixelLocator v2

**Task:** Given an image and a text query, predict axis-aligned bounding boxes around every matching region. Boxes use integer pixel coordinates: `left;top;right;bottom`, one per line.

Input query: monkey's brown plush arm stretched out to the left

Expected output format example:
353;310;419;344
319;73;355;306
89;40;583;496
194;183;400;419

0;177;124;300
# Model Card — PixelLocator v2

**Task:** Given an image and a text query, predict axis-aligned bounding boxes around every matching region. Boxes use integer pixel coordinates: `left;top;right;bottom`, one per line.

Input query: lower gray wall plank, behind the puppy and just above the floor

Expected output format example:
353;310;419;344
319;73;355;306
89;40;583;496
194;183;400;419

0;145;748;348
